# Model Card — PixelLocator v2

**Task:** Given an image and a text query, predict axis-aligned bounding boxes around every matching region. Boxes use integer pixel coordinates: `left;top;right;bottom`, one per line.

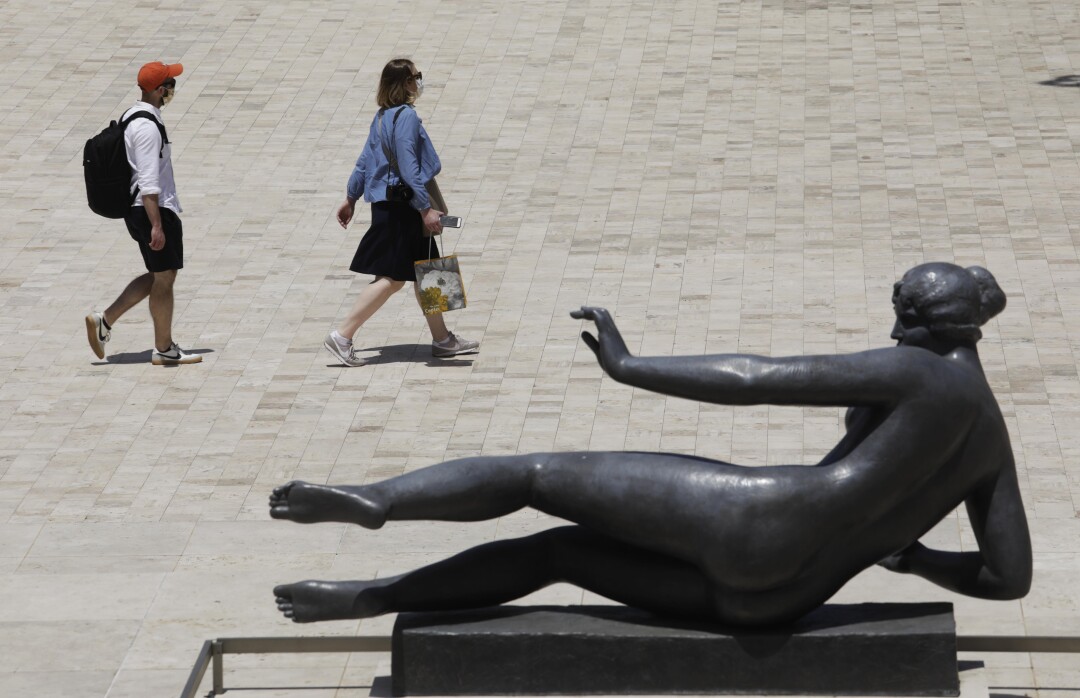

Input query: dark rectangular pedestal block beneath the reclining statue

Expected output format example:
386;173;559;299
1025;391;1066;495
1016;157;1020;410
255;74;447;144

391;603;959;696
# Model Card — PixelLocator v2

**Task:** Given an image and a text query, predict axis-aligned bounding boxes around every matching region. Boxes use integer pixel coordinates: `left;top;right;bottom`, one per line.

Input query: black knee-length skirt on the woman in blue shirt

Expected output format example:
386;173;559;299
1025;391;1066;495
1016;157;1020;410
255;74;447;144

349;201;438;281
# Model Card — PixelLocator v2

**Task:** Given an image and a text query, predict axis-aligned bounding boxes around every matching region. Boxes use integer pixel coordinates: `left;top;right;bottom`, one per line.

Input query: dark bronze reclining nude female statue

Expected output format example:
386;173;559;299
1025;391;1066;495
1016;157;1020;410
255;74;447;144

270;264;1031;626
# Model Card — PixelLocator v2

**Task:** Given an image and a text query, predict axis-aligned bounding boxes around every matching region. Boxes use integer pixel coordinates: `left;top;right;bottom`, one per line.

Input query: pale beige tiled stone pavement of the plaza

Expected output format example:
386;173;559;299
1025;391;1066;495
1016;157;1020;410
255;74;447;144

0;0;1080;698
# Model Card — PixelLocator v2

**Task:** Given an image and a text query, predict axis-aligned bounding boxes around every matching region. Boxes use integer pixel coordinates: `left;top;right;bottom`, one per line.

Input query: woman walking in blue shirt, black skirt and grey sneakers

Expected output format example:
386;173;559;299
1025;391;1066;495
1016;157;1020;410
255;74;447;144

323;58;480;366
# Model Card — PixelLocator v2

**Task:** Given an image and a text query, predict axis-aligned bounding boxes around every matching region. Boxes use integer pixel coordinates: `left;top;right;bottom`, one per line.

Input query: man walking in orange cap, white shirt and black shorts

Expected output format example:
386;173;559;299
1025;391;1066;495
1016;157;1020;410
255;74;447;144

86;62;202;366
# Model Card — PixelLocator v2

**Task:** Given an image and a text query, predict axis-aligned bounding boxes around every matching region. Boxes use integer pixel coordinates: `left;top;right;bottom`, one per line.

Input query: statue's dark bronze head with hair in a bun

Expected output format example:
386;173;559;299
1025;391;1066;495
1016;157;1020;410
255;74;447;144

892;261;1005;344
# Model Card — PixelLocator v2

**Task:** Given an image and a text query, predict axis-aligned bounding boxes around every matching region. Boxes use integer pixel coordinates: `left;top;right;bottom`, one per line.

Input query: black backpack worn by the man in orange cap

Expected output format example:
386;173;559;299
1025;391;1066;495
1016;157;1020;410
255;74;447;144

82;111;168;218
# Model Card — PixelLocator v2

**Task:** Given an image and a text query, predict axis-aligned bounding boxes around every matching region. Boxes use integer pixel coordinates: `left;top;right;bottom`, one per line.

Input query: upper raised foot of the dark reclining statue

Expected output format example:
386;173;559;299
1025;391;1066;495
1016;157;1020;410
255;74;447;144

270;480;387;528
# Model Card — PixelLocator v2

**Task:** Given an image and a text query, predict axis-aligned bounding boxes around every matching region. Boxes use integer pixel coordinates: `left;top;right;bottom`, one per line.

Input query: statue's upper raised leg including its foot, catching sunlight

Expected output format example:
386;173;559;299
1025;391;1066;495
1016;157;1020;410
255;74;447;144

270;452;734;563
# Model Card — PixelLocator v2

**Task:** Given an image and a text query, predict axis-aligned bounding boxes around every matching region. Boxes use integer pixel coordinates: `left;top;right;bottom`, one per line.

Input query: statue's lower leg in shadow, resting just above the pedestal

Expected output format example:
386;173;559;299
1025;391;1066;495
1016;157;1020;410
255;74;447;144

274;526;715;622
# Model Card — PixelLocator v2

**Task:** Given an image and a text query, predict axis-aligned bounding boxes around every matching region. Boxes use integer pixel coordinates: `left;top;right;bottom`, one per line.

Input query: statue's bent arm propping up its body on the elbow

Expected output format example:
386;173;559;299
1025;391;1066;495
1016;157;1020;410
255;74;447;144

880;464;1031;600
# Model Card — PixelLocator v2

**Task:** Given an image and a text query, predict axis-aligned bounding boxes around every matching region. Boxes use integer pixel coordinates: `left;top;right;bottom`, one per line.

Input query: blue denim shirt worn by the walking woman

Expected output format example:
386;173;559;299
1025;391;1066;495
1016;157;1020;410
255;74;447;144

346;105;443;211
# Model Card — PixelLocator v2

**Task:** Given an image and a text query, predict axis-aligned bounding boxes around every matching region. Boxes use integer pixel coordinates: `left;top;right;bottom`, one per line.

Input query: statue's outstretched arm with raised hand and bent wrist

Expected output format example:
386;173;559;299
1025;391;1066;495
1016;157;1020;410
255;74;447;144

570;307;931;406
